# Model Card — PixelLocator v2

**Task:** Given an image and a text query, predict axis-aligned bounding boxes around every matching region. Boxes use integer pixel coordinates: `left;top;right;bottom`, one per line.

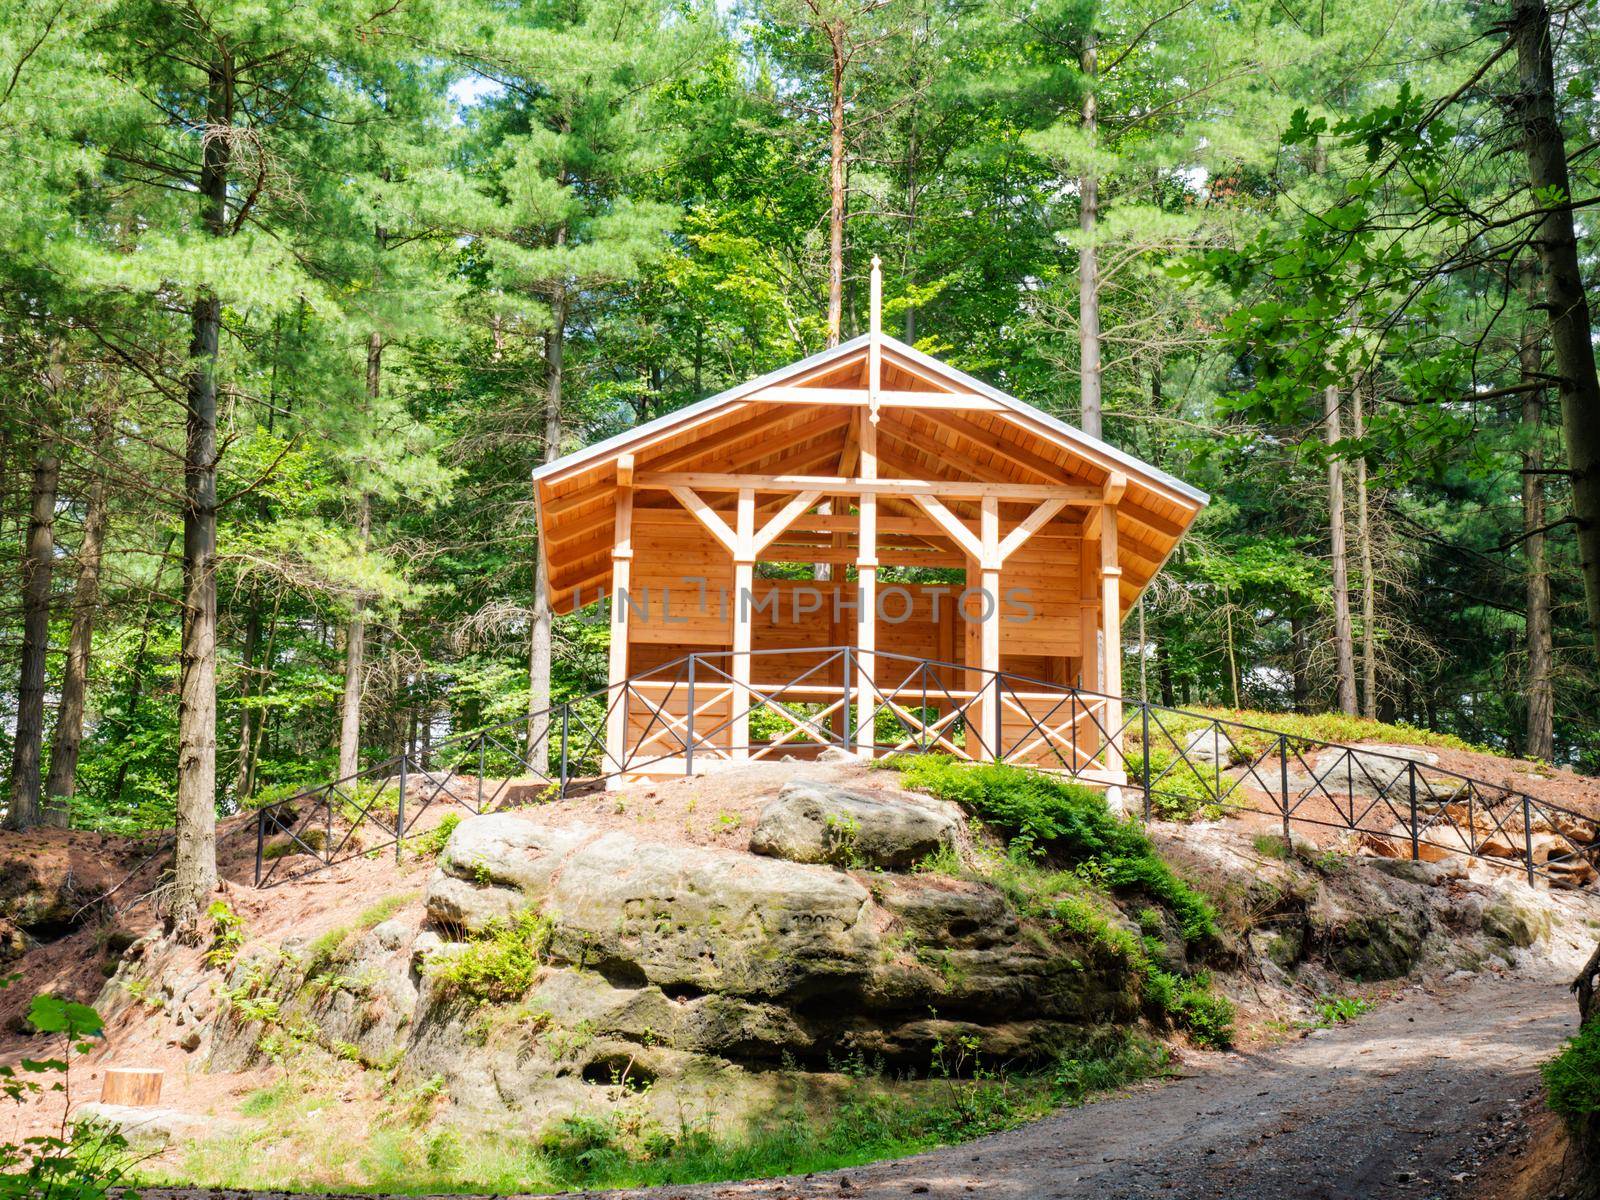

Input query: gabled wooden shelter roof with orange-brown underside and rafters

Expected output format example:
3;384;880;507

533;336;1208;611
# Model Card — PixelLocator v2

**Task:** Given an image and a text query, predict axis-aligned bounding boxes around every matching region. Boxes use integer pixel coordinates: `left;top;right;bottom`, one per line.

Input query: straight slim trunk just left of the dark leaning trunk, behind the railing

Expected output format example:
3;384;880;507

1518;284;1555;762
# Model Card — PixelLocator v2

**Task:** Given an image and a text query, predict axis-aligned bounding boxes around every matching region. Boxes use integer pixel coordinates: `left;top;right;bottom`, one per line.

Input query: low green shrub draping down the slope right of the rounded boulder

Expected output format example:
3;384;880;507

893;755;1218;942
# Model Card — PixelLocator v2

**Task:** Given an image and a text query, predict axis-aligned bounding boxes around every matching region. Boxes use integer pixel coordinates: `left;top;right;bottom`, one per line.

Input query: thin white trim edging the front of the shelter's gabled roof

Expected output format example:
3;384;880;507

533;334;1211;506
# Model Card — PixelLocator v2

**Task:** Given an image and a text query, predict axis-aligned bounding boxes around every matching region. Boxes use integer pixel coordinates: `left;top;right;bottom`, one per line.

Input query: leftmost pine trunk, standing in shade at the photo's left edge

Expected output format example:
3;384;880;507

6;419;62;829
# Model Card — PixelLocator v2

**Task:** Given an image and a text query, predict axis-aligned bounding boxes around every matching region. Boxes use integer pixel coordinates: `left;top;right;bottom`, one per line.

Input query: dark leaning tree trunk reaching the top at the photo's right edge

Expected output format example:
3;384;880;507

1510;0;1600;654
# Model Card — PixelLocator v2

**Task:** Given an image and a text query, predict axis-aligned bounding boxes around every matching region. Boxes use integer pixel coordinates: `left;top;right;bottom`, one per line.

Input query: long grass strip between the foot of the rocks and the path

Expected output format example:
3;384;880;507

141;1029;1168;1194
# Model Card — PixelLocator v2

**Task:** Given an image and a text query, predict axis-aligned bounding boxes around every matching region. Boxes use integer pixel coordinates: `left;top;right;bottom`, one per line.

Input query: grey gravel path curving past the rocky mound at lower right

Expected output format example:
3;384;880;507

142;978;1576;1200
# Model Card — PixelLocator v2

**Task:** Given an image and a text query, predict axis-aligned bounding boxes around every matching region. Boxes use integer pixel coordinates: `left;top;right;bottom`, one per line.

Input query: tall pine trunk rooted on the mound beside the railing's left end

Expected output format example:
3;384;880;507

171;61;234;942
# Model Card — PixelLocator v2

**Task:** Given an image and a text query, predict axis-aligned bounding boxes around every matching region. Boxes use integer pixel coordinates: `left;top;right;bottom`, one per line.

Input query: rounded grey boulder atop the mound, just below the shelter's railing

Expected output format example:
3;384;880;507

750;779;960;869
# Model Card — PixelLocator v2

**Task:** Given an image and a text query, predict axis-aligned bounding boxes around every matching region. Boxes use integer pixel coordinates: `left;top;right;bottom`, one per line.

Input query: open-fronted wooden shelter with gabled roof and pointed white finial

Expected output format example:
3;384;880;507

534;267;1206;782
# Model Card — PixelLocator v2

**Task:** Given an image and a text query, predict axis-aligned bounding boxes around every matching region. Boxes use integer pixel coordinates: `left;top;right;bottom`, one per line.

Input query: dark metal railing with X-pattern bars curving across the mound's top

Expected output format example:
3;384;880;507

256;646;1600;886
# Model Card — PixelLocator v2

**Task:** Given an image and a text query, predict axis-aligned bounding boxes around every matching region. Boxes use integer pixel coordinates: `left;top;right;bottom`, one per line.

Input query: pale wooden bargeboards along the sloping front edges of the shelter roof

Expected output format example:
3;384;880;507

533;333;1211;507
